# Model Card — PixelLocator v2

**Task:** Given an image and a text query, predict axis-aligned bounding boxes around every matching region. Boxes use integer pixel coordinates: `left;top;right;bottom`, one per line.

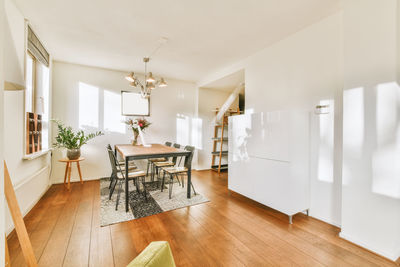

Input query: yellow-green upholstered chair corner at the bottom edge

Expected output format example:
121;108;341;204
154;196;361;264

127;241;175;267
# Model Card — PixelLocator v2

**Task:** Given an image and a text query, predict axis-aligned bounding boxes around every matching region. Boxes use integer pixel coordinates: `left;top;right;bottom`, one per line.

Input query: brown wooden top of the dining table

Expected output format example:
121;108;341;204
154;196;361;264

115;144;187;158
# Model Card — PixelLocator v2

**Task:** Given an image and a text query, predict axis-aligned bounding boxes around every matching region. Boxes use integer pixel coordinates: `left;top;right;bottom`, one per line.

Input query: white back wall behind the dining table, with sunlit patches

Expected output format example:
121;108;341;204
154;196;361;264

52;61;197;183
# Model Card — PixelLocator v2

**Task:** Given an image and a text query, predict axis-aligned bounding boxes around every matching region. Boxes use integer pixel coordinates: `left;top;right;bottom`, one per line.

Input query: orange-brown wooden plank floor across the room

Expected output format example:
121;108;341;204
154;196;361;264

8;171;396;267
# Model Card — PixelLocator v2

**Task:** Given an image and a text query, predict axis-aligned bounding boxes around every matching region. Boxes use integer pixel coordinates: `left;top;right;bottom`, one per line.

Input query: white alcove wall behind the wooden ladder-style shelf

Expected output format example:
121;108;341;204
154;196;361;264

197;88;238;170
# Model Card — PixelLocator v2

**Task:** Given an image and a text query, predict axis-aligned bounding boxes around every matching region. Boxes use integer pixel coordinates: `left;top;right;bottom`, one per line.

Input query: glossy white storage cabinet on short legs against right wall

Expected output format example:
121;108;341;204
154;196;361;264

228;111;310;222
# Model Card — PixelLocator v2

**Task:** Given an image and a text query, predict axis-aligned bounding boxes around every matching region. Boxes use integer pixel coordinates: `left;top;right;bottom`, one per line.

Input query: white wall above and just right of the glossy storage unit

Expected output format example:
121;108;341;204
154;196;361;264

199;13;343;225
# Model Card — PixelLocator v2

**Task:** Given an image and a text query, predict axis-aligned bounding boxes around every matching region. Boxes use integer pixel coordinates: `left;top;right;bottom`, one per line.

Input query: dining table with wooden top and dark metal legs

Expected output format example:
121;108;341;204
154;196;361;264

115;144;192;212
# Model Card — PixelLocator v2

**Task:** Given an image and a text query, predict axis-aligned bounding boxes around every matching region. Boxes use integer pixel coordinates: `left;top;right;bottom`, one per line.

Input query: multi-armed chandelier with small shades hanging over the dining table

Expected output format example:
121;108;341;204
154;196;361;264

125;57;167;98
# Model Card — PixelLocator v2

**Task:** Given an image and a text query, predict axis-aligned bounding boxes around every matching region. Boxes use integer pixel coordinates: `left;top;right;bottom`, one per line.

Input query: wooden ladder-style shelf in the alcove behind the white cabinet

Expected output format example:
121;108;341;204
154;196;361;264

211;108;240;174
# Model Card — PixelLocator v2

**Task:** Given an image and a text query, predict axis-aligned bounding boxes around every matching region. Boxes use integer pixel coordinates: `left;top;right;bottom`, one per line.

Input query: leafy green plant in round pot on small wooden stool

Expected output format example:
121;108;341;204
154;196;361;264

52;120;103;160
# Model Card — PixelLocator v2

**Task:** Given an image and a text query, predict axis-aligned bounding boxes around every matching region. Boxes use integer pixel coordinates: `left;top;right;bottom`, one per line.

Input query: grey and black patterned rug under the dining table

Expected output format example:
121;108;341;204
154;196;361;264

100;178;209;226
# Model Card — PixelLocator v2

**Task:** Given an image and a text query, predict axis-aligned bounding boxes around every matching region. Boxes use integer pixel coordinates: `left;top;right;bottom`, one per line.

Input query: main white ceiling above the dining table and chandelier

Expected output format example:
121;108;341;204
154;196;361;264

14;0;340;81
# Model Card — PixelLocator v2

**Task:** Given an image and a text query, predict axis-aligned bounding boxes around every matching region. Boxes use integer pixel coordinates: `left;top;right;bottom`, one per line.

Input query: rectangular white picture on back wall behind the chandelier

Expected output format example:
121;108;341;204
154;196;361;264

121;91;150;116
